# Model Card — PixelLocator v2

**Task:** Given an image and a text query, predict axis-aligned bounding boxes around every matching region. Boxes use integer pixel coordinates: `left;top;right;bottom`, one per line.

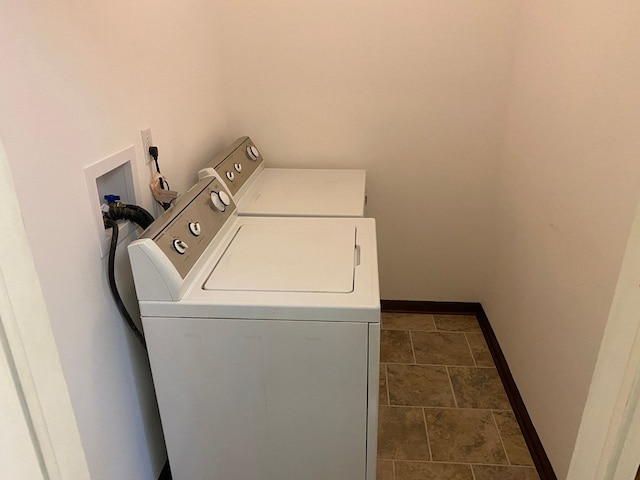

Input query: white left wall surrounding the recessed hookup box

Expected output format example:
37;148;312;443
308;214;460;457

0;4;233;480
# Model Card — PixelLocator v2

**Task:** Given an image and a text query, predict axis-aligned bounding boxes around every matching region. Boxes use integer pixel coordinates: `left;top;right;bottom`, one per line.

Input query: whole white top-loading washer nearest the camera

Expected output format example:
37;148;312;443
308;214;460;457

129;177;380;480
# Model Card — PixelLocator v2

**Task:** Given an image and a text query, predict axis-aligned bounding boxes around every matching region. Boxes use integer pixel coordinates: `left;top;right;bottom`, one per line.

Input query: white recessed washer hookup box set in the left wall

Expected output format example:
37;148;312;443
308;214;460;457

84;145;137;258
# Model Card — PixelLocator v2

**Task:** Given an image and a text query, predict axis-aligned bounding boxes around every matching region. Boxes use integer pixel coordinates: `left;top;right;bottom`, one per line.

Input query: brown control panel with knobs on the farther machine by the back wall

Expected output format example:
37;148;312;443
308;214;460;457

207;137;264;195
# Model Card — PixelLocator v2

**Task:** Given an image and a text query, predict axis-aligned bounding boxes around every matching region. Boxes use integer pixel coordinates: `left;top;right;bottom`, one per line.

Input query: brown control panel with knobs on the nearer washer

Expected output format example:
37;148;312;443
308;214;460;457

140;177;236;279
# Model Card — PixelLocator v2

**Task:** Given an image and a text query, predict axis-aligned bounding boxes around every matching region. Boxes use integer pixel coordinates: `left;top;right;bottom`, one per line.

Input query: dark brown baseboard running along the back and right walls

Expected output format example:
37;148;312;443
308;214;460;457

380;300;558;480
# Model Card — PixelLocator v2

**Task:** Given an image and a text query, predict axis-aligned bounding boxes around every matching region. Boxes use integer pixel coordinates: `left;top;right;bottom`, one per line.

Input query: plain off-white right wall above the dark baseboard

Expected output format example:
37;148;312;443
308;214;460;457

483;0;640;478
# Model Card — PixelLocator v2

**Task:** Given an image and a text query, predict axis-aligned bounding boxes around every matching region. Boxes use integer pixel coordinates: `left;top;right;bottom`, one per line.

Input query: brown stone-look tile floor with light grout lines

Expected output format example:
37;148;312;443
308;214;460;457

378;313;538;480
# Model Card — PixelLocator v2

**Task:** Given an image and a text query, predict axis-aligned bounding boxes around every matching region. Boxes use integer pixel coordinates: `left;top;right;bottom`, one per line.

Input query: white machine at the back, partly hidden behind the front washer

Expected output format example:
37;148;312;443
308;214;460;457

199;137;366;217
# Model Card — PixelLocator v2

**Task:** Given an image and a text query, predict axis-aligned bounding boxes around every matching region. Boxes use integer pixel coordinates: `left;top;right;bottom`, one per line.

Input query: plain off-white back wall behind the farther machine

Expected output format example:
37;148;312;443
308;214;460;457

210;0;519;301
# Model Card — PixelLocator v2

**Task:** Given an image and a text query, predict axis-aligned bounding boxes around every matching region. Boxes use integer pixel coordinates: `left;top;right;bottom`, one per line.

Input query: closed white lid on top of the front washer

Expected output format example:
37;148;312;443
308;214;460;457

204;224;356;293
